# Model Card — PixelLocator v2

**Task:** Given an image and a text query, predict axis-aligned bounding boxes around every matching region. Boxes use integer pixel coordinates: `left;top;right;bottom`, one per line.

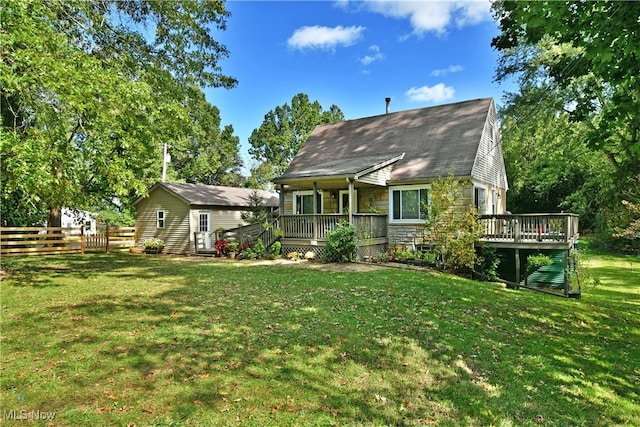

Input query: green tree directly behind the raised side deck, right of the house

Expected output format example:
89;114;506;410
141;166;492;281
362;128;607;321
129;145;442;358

500;87;615;229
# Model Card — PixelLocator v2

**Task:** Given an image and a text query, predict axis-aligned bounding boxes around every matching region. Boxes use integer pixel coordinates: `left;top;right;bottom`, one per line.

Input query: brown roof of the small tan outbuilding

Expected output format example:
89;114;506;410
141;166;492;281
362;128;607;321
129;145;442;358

133;182;279;207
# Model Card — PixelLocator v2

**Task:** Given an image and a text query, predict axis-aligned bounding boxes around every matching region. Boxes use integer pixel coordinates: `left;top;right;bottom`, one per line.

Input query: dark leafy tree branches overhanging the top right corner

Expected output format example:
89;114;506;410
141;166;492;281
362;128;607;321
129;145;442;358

492;1;640;172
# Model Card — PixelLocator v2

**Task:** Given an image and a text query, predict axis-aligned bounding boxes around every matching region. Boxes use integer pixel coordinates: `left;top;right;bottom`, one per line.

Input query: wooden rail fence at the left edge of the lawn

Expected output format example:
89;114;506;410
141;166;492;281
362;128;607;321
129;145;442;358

0;227;136;256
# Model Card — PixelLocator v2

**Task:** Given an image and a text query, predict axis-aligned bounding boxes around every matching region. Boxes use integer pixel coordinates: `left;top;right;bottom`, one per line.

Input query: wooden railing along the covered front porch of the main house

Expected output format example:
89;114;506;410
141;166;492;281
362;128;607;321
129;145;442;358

280;214;387;240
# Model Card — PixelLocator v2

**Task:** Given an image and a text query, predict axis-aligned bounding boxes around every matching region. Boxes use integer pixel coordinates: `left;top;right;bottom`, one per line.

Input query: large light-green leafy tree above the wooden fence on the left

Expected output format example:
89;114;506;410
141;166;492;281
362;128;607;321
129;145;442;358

0;1;236;226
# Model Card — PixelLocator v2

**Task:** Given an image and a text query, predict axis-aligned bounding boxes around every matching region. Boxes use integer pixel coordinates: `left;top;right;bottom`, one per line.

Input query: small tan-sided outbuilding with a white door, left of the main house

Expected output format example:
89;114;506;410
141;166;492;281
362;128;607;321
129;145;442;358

133;182;278;254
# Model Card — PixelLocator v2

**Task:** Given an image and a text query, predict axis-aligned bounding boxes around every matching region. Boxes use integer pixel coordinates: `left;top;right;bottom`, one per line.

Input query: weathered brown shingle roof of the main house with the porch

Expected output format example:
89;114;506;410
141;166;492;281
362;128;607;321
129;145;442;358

274;98;493;183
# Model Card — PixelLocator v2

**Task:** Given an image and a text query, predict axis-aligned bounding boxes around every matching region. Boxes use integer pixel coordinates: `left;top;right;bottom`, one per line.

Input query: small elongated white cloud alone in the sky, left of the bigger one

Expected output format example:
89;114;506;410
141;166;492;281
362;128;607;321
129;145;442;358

287;25;365;50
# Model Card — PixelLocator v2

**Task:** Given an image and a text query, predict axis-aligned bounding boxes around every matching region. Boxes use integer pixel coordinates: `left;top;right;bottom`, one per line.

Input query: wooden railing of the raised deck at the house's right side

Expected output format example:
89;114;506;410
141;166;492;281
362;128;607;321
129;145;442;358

479;213;578;243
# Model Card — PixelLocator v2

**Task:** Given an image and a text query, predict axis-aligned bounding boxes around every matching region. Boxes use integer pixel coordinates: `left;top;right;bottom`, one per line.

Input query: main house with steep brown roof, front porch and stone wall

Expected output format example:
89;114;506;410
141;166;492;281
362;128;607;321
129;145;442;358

274;98;508;256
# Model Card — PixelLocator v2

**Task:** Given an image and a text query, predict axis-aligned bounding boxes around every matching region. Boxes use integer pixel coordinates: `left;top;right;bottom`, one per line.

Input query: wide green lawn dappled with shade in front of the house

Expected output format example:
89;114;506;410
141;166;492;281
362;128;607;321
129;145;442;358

0;249;640;426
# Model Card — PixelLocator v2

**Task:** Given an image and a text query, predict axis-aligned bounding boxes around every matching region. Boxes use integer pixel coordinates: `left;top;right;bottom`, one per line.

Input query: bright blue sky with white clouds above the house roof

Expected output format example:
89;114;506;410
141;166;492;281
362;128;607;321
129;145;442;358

206;0;507;170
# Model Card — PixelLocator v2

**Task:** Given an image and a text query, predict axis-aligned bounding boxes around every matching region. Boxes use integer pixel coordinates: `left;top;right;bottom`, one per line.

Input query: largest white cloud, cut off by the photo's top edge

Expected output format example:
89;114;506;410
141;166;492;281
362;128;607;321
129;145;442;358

337;0;491;36
